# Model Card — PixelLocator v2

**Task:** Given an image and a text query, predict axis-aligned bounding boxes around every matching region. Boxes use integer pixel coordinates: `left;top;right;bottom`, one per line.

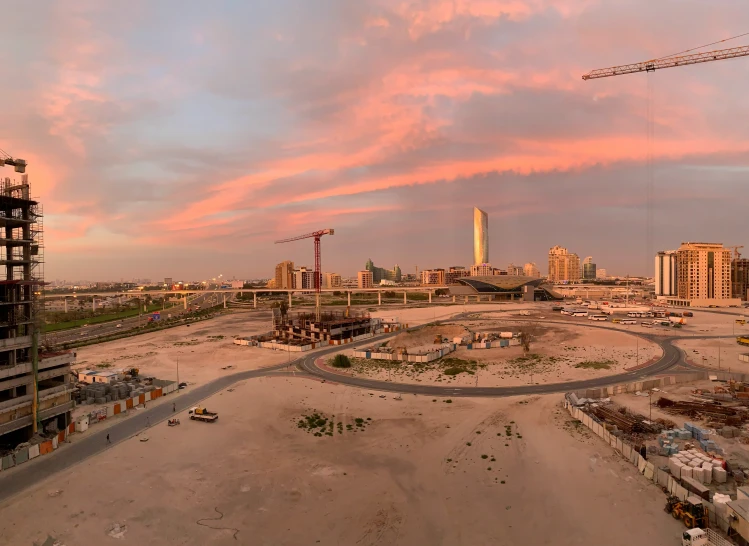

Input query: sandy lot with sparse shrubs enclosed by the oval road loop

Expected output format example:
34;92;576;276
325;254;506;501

336;320;662;387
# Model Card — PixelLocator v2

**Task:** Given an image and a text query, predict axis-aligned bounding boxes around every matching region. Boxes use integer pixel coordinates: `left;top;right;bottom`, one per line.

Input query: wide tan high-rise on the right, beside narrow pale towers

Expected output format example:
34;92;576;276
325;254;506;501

676;243;731;300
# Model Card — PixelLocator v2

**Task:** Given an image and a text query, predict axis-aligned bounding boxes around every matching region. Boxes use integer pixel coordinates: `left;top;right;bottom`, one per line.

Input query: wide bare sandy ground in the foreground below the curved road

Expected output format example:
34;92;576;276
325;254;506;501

0;377;683;546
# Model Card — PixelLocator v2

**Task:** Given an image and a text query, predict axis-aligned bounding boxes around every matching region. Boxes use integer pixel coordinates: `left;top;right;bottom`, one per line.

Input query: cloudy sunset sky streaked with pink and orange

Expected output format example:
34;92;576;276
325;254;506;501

0;0;749;280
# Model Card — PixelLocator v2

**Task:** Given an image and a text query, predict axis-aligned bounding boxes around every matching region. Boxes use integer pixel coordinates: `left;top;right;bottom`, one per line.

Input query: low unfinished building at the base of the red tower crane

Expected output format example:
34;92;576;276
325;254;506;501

273;308;379;345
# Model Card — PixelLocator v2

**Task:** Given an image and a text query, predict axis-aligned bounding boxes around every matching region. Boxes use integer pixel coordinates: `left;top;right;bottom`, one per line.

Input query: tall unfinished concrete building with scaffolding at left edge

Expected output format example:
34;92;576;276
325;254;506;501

0;174;75;452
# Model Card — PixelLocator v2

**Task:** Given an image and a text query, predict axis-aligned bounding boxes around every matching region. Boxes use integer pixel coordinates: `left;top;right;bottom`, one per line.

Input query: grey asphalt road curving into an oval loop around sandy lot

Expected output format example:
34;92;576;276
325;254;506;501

0;315;726;502
